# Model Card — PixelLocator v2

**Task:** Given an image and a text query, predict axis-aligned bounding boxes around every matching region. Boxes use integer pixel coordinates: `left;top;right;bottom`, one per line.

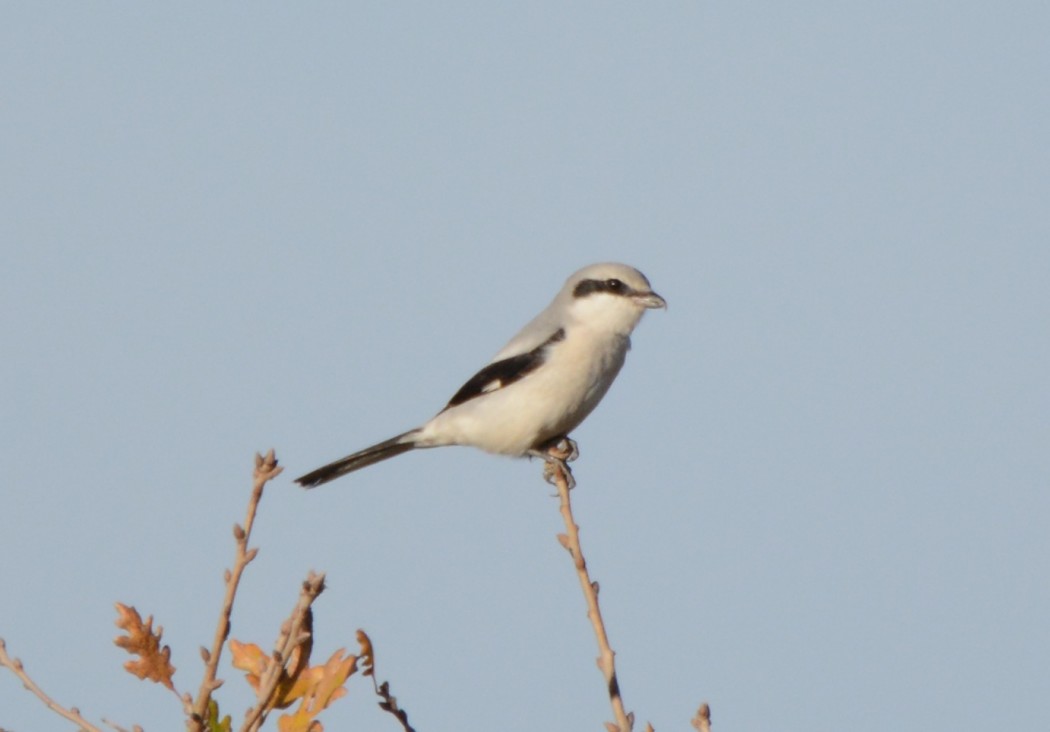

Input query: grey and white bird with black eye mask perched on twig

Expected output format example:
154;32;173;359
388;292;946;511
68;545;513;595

295;263;667;488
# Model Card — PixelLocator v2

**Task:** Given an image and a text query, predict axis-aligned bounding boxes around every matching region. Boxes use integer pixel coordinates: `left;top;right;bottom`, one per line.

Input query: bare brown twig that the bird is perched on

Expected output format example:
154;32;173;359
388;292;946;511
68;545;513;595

548;447;634;732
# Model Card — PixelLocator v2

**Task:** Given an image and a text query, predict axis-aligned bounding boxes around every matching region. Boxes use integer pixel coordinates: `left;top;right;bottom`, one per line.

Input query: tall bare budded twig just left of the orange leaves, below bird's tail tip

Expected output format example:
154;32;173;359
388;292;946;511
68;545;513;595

187;449;284;732
